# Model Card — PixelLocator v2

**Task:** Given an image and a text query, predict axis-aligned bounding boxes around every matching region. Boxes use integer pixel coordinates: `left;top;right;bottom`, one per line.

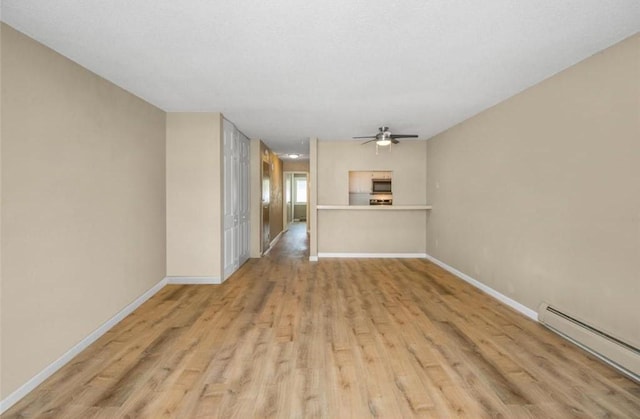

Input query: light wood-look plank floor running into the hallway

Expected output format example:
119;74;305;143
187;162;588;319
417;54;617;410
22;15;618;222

3;224;640;419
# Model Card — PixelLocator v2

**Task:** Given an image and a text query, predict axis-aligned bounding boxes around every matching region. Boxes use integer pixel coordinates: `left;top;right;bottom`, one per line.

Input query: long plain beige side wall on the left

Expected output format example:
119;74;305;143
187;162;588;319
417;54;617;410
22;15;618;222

0;24;165;398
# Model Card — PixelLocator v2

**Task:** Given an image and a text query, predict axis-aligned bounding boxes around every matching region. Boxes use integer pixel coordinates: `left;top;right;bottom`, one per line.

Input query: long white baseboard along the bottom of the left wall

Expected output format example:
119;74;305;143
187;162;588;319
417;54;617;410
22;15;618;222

0;278;167;414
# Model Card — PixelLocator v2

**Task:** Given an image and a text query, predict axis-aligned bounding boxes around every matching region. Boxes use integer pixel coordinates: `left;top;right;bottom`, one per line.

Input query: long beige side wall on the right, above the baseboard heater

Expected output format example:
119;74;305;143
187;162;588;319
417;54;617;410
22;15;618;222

427;35;640;347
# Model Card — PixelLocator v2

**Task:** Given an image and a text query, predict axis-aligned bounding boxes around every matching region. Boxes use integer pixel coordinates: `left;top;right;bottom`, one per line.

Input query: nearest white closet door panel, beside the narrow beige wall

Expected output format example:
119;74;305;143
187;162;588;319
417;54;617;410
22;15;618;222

222;119;240;279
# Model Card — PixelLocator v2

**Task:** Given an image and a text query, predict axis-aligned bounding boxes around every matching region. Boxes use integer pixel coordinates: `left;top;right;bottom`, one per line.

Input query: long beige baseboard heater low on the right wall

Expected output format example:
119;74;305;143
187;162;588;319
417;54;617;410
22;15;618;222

538;303;640;382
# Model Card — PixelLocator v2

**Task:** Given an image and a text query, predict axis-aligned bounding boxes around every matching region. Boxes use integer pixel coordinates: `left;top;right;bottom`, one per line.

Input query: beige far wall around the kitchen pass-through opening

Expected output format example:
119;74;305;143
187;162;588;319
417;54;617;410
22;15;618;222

311;141;427;255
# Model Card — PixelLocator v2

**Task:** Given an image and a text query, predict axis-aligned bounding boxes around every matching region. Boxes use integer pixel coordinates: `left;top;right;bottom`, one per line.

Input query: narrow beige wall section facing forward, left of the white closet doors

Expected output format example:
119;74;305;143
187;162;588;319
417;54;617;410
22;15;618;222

166;113;222;278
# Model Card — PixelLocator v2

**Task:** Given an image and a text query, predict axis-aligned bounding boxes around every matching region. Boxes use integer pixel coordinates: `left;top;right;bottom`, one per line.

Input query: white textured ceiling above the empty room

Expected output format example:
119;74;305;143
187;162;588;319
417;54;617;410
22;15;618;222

1;0;640;158
